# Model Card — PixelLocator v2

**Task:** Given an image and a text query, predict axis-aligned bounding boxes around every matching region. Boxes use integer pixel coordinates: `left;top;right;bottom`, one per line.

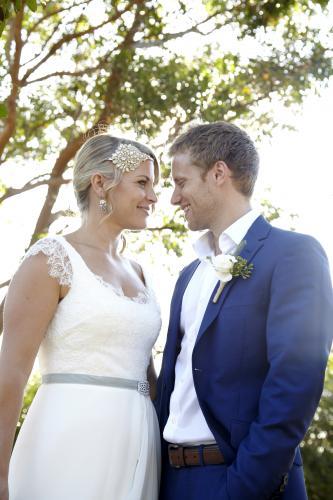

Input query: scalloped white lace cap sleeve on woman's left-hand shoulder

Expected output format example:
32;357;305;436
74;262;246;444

24;238;73;286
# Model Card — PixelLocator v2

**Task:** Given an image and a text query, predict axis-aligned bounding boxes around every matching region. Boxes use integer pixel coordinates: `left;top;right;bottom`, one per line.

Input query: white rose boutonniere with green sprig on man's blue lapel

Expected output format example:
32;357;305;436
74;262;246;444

208;247;253;304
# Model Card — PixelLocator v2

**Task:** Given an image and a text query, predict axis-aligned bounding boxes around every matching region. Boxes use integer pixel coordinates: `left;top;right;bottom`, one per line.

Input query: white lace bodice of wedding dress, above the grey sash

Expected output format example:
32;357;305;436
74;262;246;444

25;236;161;380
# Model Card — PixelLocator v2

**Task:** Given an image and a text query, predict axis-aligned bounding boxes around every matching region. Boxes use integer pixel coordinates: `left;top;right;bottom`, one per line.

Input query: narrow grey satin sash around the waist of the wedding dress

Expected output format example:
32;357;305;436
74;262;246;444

42;373;149;396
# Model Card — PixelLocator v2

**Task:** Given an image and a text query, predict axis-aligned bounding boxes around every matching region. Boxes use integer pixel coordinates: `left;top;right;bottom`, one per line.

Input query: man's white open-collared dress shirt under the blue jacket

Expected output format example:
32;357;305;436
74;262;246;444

163;210;259;444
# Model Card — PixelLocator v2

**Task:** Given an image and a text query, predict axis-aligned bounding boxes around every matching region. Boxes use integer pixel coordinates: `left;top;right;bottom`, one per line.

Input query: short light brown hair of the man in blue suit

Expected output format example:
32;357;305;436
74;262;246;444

169;121;259;196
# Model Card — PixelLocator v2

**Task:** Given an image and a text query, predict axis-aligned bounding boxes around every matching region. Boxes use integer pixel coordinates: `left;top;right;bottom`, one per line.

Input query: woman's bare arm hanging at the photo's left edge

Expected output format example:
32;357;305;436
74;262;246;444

0;254;61;500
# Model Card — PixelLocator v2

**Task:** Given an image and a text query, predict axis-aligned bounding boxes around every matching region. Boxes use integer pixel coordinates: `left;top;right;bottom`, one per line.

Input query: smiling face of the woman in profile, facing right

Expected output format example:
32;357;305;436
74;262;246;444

107;160;157;229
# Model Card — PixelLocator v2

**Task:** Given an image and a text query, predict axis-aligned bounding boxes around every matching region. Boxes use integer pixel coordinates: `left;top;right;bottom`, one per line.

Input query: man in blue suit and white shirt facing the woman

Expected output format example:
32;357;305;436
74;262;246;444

156;122;333;500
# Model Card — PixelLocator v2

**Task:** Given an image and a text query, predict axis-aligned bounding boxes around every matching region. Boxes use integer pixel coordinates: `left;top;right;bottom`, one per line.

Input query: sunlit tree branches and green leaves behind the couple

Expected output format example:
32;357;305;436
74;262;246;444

0;0;333;500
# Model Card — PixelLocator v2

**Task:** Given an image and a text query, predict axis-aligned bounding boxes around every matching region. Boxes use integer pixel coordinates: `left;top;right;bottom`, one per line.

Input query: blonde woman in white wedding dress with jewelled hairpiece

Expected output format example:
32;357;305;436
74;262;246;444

0;133;161;500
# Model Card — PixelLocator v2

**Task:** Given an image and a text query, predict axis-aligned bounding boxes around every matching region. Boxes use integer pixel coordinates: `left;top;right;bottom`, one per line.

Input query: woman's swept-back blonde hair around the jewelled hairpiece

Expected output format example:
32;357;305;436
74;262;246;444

73;132;159;217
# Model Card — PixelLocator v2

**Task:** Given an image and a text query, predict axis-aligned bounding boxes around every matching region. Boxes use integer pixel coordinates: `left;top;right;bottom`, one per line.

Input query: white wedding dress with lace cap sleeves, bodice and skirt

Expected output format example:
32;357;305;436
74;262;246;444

9;236;161;500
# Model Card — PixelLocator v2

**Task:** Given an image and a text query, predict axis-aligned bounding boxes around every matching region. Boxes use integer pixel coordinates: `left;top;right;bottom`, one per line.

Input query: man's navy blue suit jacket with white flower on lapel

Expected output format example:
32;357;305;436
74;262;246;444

156;217;333;500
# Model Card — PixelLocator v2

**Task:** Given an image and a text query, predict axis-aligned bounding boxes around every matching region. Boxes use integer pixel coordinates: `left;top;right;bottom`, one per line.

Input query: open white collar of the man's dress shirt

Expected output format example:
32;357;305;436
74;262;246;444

193;209;260;260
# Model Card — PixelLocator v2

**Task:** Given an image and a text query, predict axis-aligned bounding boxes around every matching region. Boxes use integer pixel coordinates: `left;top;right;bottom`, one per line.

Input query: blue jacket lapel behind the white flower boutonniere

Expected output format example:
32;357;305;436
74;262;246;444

196;216;271;344
